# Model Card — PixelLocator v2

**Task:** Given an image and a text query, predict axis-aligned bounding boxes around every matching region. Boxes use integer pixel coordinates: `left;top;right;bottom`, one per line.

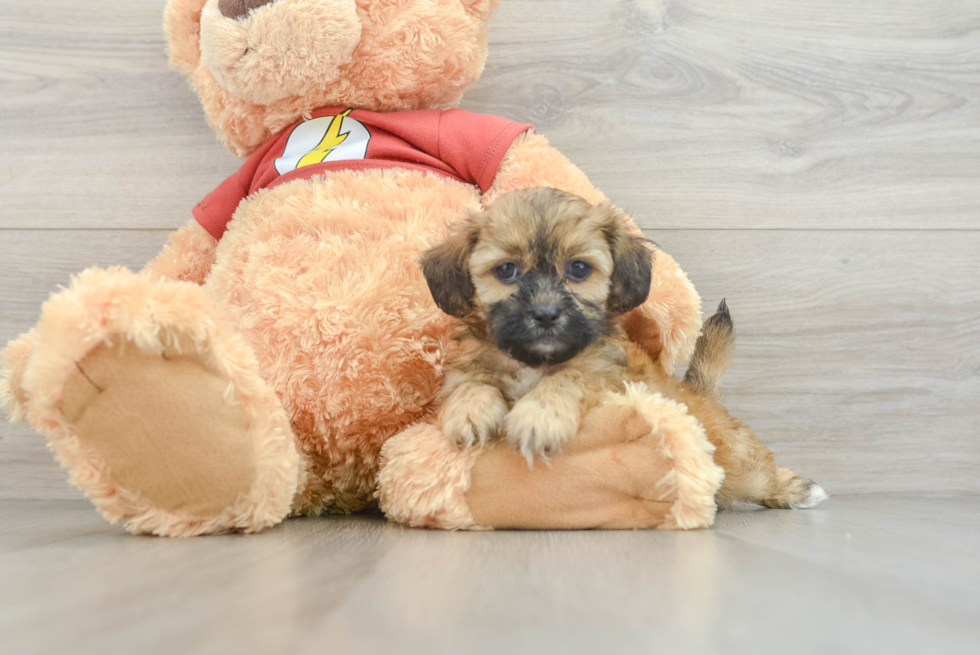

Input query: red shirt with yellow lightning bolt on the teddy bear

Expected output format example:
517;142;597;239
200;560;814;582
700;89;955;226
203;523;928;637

194;107;534;239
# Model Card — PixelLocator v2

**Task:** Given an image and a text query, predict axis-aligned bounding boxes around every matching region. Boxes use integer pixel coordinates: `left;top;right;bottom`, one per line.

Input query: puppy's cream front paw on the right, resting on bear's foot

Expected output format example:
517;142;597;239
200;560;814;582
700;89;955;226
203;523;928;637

504;396;579;466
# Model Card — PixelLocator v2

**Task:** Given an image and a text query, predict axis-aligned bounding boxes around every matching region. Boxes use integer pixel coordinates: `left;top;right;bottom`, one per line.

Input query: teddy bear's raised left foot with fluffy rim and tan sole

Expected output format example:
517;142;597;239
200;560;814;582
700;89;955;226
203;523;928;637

9;269;300;536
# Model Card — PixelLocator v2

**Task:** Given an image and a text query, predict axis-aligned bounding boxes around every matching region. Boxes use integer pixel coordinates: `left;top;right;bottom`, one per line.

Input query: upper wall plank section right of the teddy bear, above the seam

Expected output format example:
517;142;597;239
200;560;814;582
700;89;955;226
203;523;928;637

464;0;980;229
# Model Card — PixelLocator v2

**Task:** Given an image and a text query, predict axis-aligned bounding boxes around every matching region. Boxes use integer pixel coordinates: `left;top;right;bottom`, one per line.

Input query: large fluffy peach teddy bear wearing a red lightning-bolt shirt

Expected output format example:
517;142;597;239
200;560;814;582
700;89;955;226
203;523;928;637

0;0;723;536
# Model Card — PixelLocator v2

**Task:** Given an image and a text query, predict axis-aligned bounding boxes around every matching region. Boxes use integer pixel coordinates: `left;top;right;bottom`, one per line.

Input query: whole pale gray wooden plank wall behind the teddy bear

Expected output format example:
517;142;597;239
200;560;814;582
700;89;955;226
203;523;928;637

0;0;980;498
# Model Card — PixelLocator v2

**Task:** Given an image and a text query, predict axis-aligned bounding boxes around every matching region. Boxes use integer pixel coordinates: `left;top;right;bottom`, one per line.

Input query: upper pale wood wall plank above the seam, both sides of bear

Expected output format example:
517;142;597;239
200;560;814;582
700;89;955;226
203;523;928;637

0;0;980;229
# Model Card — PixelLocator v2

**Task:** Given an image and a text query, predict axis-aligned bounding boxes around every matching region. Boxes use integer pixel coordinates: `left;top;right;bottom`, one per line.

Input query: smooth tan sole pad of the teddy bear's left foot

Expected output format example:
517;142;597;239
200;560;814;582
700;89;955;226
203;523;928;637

63;342;264;517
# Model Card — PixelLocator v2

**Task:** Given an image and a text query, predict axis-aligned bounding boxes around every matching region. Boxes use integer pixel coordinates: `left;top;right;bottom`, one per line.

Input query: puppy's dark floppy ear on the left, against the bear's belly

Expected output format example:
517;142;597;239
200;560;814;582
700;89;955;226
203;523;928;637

422;215;480;318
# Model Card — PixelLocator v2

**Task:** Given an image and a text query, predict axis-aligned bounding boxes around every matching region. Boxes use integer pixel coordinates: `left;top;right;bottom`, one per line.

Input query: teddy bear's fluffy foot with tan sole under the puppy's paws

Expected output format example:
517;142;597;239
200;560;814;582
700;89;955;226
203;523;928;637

379;385;724;530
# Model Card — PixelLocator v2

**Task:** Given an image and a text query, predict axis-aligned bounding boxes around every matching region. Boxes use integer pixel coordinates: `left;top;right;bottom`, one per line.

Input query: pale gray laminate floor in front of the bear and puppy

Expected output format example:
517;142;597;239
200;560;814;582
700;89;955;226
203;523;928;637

0;495;980;655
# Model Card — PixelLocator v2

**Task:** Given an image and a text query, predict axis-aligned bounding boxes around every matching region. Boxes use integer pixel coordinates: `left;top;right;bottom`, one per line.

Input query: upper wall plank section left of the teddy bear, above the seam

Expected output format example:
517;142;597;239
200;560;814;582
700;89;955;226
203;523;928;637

0;0;241;229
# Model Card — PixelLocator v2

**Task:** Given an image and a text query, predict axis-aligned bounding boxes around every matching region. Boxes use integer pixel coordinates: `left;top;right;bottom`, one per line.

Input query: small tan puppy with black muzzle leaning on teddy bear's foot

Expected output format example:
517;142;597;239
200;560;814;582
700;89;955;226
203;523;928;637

422;188;827;508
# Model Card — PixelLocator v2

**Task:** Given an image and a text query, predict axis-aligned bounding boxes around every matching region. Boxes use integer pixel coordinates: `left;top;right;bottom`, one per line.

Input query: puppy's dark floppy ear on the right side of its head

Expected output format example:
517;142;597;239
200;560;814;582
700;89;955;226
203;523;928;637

596;203;653;314
